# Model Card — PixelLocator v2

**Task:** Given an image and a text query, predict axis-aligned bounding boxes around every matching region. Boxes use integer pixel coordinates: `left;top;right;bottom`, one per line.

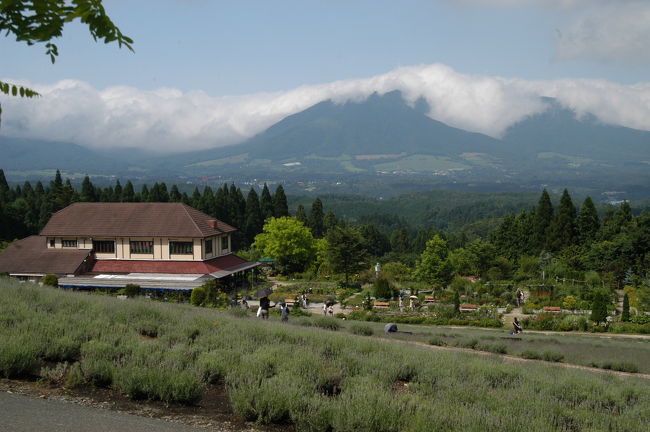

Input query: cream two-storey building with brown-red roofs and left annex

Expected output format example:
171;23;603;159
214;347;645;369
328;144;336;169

0;203;258;289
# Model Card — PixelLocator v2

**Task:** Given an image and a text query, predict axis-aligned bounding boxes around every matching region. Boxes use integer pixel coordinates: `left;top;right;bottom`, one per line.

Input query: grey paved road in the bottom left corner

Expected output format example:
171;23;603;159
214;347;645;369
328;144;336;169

0;392;217;432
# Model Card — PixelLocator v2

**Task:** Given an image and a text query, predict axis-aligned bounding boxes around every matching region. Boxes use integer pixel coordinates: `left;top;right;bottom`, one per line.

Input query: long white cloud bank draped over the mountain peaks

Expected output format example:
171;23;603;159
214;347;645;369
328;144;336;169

2;64;650;153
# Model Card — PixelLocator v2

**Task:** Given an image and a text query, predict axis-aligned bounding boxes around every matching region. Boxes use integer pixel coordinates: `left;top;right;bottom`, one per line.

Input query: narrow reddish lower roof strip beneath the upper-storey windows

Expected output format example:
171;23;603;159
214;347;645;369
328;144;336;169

90;254;247;274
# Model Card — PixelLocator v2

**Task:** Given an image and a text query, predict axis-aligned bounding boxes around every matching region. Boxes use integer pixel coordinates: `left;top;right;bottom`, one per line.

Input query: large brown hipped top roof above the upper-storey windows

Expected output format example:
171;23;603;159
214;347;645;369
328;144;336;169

41;203;236;238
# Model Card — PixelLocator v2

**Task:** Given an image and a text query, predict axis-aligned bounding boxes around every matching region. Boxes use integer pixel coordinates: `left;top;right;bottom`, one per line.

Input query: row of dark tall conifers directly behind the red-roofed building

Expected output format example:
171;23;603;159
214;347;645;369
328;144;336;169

0;169;289;248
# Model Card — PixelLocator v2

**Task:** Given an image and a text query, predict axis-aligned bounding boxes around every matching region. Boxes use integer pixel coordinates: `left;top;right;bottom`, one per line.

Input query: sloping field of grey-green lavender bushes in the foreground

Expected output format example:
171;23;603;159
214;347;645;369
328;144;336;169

0;280;650;432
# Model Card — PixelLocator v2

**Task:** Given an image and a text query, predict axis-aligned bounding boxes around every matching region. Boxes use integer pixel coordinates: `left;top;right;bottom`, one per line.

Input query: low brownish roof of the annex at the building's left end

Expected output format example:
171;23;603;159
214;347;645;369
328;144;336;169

0;236;90;274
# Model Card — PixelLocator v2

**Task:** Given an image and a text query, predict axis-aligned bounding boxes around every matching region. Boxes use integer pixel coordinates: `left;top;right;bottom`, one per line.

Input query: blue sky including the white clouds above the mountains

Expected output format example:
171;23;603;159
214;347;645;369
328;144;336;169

0;0;650;151
